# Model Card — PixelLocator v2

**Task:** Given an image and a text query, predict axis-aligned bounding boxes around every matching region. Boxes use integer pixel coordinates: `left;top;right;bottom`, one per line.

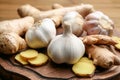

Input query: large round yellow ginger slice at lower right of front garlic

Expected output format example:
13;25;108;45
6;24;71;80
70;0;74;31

72;57;96;77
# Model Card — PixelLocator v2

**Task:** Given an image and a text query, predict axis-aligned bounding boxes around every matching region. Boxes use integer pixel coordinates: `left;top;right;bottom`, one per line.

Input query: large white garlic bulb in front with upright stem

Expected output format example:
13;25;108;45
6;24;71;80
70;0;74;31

47;22;85;64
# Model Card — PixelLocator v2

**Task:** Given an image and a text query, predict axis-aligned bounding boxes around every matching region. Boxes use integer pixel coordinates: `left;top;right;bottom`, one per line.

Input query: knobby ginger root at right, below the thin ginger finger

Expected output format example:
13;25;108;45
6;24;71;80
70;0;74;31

86;45;120;68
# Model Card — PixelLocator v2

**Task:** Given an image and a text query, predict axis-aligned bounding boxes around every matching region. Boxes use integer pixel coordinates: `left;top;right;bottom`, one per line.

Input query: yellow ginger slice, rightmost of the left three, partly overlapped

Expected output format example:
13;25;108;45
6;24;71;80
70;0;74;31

28;53;48;66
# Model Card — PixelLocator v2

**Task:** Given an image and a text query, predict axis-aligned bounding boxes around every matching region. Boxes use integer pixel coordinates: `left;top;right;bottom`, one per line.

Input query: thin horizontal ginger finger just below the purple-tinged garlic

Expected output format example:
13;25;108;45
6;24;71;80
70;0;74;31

80;35;116;45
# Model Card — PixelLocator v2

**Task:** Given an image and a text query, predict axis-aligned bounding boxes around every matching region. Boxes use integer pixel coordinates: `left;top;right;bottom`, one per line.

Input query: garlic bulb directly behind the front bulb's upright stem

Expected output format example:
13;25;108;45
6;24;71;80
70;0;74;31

62;11;84;36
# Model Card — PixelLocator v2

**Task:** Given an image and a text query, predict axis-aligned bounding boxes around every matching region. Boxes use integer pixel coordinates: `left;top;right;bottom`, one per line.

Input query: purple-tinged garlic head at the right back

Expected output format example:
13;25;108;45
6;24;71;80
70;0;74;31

83;11;114;36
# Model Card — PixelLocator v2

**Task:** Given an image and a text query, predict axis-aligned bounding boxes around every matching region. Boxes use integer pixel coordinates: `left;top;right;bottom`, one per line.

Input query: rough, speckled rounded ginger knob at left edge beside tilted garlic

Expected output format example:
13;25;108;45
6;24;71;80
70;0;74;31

0;32;27;54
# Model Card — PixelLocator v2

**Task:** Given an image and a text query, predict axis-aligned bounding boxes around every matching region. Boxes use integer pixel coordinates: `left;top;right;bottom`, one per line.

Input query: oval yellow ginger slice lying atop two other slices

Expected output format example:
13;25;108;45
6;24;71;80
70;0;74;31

20;49;38;59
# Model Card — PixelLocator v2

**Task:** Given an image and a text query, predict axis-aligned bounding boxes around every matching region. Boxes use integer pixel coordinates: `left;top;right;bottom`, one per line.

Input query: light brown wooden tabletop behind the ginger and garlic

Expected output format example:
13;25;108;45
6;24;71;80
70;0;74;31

0;0;120;80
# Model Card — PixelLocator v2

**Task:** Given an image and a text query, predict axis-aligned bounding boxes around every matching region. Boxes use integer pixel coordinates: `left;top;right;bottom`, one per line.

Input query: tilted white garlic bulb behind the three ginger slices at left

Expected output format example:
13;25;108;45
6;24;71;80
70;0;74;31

25;18;56;48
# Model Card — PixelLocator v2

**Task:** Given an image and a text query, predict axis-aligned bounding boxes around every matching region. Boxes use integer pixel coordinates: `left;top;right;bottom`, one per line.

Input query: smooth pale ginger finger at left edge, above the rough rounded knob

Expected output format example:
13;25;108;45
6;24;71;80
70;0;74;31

0;17;34;35
